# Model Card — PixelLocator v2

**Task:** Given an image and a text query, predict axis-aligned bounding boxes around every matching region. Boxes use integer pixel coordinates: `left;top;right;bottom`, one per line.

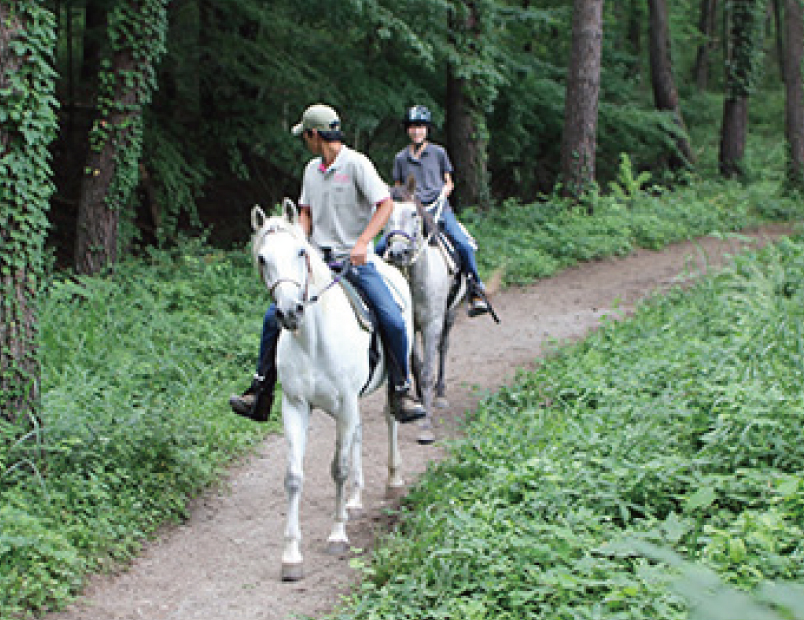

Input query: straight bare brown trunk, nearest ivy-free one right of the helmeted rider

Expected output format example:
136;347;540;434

561;0;603;199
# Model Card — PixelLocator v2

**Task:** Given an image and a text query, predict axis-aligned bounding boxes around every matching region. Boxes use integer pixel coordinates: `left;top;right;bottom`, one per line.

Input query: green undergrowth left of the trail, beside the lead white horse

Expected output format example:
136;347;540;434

0;242;278;618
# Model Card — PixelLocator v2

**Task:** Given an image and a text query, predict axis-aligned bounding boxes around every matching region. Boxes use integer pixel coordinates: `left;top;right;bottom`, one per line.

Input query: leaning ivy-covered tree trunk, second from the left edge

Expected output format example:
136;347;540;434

75;0;167;274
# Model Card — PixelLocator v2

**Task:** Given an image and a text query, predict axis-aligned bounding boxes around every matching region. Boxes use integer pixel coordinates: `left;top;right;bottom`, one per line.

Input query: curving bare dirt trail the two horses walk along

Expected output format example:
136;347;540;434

45;226;790;620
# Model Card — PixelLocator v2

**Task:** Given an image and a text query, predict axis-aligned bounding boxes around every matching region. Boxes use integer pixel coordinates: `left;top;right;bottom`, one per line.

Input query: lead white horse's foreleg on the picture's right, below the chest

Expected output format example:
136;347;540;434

327;404;360;554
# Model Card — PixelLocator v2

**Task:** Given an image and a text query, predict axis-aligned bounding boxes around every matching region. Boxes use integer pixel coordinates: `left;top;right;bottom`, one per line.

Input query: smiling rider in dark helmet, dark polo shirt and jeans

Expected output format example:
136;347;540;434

392;105;490;317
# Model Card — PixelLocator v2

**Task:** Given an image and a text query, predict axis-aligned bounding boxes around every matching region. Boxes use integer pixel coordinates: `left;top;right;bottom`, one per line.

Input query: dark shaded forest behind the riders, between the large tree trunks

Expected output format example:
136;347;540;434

48;0;796;266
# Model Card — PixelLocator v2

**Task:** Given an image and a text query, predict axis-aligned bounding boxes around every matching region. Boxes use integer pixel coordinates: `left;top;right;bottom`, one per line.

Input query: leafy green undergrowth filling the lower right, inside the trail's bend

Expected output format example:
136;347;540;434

332;239;804;620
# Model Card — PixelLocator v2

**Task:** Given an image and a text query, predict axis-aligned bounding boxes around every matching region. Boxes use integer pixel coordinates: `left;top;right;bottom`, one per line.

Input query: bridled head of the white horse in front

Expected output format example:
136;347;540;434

251;198;313;330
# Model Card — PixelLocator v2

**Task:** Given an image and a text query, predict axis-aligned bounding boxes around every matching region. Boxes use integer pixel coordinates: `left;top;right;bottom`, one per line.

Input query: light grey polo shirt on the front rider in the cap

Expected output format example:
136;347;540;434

299;145;390;254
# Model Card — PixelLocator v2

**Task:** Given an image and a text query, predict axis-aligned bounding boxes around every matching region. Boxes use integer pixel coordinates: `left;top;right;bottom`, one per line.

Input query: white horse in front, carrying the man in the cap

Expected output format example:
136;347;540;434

251;198;413;581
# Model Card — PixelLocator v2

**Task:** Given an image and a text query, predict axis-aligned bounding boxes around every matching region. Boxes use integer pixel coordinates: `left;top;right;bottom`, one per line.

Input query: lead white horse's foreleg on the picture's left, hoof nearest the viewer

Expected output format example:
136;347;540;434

282;395;310;581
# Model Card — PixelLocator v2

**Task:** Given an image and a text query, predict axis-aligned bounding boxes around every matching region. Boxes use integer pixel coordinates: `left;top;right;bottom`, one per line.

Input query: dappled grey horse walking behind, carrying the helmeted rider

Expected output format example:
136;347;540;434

383;177;467;444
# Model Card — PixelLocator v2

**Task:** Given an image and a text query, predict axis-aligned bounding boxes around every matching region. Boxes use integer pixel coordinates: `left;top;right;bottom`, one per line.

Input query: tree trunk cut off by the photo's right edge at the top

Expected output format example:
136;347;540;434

784;0;804;190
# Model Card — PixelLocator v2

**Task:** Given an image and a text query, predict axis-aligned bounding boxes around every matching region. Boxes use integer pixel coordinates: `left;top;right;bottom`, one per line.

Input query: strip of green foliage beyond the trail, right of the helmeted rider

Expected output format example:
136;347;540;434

461;168;802;285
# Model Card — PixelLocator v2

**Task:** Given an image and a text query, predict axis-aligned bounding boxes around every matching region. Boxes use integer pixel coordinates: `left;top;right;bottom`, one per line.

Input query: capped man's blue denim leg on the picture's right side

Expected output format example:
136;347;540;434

352;263;409;387
